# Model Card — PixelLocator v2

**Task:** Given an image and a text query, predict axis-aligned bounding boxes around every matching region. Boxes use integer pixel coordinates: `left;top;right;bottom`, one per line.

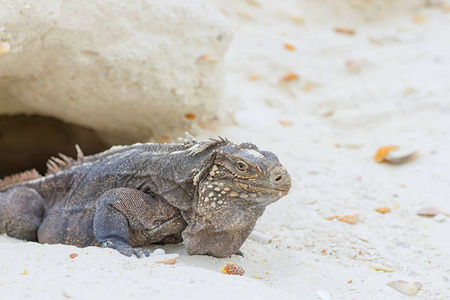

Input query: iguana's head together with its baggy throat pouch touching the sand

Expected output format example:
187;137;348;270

183;138;291;257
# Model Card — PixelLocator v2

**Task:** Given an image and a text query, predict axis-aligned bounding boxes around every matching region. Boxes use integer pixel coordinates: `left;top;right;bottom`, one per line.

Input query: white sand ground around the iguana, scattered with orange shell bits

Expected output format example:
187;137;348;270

0;0;450;299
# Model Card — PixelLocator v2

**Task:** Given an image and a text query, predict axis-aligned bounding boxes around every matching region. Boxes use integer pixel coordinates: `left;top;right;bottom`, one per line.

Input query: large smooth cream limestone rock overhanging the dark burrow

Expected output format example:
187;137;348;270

0;0;232;140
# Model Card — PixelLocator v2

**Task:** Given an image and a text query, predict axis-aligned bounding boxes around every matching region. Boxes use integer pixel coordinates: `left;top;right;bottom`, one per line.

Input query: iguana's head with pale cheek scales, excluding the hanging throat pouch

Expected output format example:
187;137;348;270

198;143;291;218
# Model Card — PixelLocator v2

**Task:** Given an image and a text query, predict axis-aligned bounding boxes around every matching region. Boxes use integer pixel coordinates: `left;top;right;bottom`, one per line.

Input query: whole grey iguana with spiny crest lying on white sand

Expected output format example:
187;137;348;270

0;135;291;257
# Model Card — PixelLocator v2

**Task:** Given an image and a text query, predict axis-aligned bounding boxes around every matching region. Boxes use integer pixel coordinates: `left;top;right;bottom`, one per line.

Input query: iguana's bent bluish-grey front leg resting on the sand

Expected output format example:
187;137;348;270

94;188;179;257
